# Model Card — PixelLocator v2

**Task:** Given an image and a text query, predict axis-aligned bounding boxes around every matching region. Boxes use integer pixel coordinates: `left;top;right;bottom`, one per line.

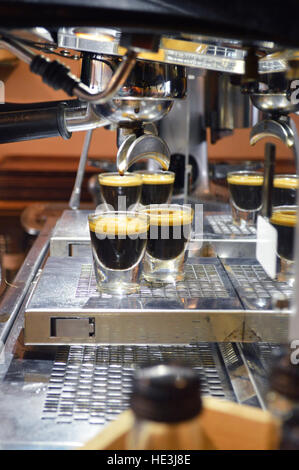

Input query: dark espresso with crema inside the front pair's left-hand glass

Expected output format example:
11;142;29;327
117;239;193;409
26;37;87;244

89;214;149;270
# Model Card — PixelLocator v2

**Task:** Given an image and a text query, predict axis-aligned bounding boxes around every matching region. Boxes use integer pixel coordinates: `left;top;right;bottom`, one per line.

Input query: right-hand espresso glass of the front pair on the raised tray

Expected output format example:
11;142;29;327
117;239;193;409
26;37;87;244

142;204;194;283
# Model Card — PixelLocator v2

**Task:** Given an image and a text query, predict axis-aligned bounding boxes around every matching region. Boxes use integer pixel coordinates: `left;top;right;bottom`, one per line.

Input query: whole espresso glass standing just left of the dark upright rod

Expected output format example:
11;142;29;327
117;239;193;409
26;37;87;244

227;171;264;226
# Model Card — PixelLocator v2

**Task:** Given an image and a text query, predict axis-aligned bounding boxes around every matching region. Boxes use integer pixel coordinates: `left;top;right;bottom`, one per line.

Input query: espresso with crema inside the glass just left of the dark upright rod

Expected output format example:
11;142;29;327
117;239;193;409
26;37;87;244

227;174;264;211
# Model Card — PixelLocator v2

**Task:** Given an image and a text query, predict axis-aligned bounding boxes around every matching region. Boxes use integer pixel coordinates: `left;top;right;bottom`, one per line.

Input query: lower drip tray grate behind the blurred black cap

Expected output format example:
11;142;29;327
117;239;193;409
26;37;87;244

42;343;235;424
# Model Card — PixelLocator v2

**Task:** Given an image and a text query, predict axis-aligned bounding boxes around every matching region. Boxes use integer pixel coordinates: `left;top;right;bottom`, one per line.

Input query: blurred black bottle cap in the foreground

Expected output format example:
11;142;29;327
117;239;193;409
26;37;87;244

130;364;202;423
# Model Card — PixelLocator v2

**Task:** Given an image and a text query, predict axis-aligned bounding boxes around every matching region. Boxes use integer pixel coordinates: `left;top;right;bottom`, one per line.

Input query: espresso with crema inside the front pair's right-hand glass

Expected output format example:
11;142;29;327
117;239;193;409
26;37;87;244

145;209;193;260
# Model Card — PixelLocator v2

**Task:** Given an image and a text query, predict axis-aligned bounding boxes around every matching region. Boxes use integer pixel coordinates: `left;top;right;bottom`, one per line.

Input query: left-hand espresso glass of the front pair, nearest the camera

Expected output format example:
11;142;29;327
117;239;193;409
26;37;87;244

88;211;149;295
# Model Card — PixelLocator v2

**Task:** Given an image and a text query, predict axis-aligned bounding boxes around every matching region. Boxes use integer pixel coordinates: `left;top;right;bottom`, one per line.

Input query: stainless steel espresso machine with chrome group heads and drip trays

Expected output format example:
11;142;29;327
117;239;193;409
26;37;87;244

0;0;299;449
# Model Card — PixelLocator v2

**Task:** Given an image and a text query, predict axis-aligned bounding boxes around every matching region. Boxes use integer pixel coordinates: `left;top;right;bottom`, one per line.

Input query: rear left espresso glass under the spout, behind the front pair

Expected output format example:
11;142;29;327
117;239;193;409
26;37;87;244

98;173;142;210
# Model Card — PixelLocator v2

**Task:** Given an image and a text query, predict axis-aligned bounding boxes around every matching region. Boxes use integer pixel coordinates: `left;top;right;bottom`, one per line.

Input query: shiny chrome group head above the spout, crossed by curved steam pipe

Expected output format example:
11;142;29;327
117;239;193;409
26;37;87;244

92;56;186;126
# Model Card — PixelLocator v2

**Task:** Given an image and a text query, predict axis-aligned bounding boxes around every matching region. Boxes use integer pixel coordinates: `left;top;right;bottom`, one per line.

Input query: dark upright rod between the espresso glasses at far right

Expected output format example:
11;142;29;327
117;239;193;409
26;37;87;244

261;143;276;219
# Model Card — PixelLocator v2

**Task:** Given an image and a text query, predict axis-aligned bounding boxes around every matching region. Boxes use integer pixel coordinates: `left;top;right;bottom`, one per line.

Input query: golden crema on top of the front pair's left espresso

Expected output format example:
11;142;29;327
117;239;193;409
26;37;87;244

89;215;149;235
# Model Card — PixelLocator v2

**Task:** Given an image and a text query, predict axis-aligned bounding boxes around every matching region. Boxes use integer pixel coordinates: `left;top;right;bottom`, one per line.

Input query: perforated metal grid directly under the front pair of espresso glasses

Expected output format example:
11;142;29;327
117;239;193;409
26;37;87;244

76;264;229;299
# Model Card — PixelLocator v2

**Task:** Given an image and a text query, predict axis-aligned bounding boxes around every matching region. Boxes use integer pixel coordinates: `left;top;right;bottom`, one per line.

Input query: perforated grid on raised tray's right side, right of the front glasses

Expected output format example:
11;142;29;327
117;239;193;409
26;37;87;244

227;264;292;299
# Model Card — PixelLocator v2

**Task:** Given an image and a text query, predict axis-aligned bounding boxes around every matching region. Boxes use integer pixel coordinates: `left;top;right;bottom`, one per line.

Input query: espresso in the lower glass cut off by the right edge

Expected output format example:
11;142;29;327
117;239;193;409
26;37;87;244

270;209;297;261
